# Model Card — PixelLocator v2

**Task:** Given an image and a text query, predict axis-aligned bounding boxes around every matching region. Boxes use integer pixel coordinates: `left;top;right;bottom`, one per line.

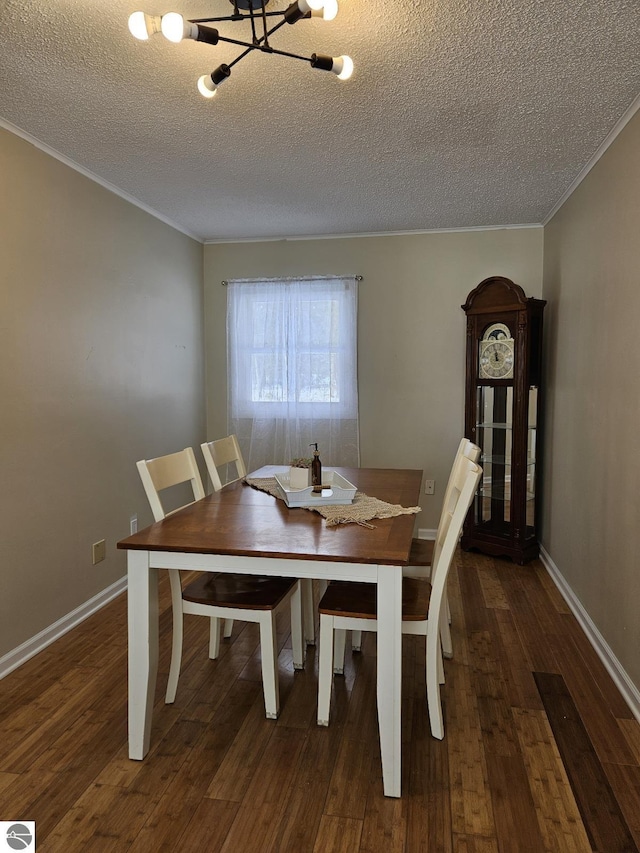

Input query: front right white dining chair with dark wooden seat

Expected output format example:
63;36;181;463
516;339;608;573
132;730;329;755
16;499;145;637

318;458;482;740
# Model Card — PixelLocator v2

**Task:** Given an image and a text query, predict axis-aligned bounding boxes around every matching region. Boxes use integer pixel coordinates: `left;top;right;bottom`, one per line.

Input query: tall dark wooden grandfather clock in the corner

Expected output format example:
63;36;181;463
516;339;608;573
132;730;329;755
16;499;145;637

462;276;546;564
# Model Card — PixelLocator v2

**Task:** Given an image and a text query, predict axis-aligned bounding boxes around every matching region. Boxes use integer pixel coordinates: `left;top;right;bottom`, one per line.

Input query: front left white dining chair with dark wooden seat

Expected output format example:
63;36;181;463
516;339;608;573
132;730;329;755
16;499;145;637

137;447;304;719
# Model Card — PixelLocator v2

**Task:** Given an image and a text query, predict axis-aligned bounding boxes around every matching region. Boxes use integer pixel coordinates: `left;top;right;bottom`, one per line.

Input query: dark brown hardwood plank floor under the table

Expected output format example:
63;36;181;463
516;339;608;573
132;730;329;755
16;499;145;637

0;552;640;853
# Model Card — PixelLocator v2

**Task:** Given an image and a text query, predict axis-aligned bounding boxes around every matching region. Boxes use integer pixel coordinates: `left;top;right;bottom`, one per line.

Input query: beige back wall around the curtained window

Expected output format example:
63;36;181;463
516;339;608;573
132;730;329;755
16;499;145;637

205;228;542;528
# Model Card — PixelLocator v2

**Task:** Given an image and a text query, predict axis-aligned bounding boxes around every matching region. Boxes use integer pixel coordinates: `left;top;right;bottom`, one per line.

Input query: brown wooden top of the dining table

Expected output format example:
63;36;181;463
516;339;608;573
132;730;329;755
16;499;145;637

118;468;422;565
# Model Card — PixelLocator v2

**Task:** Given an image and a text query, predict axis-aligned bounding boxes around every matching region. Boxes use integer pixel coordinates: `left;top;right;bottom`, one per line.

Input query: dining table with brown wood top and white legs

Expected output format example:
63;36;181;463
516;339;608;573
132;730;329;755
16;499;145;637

118;466;422;797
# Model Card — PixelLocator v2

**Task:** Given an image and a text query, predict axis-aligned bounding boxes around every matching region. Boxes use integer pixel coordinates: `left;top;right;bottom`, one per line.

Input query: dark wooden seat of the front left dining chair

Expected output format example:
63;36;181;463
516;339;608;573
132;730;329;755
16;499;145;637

182;573;296;610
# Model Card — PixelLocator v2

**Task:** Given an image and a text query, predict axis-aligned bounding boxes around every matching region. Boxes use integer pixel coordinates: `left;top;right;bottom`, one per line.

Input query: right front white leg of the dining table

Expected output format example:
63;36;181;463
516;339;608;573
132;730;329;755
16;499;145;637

377;566;402;797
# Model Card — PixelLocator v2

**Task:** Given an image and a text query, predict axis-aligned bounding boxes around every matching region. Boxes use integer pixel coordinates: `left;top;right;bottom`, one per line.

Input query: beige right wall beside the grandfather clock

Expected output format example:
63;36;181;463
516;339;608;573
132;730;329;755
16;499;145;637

542;113;640;685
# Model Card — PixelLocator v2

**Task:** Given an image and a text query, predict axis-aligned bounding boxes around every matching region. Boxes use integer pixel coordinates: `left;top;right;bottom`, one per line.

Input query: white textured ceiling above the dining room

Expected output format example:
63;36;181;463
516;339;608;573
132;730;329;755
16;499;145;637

0;0;640;240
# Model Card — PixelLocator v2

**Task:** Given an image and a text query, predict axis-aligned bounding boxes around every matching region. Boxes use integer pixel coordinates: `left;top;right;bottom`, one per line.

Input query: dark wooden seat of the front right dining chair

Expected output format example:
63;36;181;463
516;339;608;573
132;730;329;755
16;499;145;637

318;578;431;622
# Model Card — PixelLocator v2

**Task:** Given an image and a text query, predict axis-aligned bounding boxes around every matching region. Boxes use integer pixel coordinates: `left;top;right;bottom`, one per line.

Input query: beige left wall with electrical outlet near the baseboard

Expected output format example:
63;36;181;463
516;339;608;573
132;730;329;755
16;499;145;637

0;130;204;657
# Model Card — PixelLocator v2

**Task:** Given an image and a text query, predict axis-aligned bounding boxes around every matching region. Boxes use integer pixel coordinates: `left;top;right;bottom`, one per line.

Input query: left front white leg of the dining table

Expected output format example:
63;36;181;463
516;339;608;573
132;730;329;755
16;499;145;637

127;550;158;760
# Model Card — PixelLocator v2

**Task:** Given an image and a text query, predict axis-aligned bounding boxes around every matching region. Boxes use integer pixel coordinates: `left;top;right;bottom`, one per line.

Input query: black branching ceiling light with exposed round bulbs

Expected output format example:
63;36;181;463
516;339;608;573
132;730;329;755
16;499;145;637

129;0;353;98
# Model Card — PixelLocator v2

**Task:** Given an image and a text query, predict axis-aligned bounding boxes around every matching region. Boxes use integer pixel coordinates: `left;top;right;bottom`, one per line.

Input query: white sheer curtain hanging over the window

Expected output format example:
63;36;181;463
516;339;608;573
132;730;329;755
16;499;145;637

227;277;360;471
